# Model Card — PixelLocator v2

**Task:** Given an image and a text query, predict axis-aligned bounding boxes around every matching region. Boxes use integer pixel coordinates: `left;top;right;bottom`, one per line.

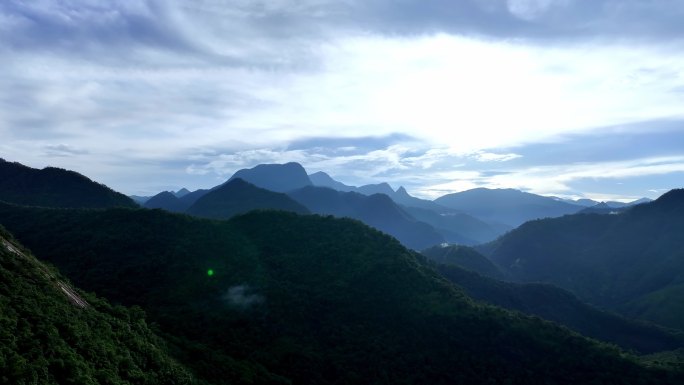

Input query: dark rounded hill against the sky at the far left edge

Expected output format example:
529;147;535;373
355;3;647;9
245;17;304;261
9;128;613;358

0;158;138;208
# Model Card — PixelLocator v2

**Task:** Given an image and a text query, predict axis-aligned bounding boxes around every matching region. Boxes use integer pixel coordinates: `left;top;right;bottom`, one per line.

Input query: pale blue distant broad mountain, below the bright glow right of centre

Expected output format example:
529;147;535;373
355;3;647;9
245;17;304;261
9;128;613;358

435;188;583;227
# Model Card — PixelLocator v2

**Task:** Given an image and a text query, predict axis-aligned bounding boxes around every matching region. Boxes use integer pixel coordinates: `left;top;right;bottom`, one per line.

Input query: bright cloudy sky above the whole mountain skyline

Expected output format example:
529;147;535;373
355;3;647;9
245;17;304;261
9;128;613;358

0;0;684;201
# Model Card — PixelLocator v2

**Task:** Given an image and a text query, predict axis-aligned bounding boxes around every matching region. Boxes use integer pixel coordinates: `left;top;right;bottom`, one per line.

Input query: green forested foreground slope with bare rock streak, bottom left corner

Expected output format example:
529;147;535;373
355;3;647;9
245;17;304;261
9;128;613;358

0;227;196;385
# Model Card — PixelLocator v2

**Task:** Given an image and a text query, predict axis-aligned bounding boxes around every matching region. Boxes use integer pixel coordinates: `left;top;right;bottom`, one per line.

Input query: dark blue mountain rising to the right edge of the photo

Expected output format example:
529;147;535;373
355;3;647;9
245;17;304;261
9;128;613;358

481;189;684;330
